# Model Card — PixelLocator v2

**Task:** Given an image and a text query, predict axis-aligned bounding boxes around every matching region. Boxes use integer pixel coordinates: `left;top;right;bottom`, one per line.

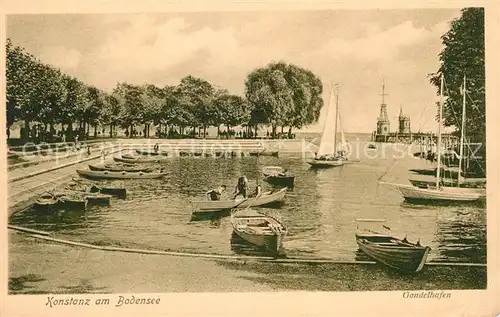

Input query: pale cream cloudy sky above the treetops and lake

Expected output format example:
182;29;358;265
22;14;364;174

7;9;460;133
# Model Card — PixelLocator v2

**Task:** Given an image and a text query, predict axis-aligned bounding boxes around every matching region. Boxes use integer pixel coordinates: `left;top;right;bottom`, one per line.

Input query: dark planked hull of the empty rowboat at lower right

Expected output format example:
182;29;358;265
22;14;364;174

356;235;431;273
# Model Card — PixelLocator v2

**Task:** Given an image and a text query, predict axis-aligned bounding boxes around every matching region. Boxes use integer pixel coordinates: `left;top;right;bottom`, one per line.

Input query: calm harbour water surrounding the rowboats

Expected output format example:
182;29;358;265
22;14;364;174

10;139;486;263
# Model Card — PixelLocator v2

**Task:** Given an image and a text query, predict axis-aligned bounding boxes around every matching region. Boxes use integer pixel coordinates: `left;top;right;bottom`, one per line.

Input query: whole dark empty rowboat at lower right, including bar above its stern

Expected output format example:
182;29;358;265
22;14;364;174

356;219;431;273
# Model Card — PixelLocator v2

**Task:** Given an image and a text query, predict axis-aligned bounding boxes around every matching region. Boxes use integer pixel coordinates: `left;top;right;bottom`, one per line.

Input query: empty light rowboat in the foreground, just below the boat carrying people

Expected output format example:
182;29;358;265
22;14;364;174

231;209;288;254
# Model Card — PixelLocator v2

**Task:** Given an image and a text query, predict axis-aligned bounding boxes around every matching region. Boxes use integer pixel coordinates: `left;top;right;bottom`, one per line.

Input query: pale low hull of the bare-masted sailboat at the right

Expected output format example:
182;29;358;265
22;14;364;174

398;186;484;202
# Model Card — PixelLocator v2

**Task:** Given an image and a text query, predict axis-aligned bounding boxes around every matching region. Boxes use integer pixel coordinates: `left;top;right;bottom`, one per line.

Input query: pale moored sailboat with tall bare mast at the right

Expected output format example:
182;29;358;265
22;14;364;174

382;74;485;203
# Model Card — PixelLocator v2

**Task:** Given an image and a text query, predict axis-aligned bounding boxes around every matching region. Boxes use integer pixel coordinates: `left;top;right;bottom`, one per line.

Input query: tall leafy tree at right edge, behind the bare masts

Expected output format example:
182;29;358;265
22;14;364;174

430;8;486;144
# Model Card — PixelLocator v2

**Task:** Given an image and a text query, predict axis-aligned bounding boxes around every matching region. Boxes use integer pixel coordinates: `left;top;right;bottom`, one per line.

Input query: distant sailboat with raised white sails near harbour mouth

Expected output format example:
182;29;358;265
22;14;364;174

307;85;347;167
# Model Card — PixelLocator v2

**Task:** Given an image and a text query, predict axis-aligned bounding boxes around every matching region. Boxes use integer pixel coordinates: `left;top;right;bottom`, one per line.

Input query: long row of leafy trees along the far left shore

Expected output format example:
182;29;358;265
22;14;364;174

6;39;323;140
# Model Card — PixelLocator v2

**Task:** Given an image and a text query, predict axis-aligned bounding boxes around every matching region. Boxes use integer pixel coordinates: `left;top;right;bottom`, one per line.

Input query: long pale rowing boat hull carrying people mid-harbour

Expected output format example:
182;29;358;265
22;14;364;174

191;187;287;213
